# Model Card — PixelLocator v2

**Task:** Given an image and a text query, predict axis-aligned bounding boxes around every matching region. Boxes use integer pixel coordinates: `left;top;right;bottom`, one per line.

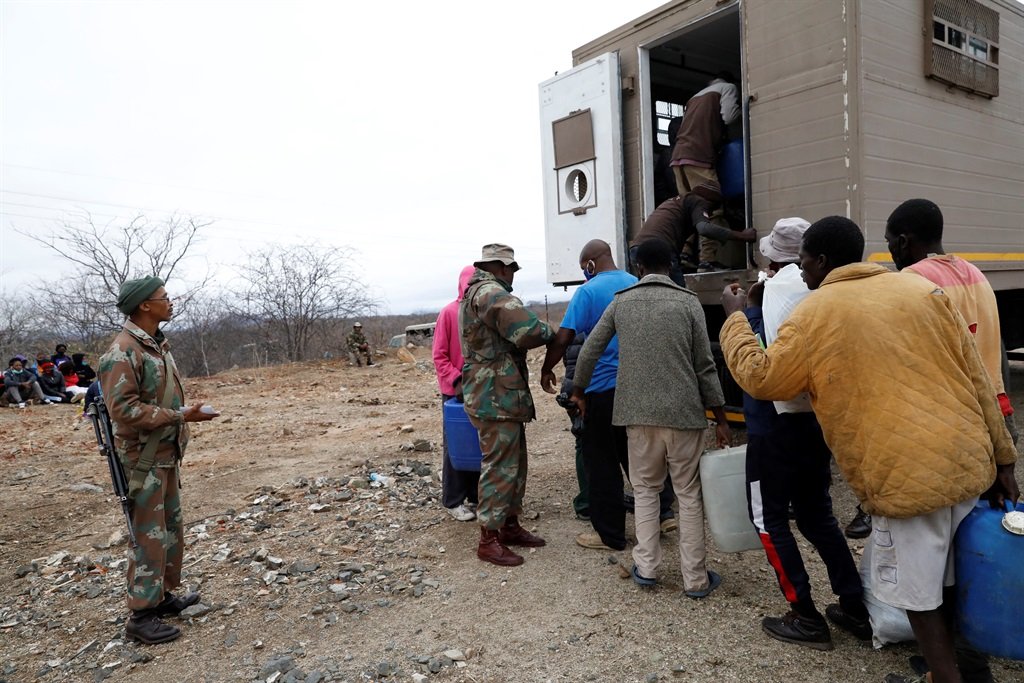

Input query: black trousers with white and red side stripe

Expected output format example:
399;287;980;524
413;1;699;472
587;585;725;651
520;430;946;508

746;413;863;603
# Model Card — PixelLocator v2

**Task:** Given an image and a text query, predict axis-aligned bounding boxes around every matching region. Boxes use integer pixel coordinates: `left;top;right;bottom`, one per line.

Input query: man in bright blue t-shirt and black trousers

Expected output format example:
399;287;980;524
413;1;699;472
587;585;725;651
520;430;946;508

541;240;674;550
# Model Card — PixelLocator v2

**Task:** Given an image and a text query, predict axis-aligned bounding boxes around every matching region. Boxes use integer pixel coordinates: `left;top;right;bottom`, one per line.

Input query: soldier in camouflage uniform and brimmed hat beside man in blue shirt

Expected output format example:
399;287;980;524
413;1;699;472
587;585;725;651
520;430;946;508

459;244;554;566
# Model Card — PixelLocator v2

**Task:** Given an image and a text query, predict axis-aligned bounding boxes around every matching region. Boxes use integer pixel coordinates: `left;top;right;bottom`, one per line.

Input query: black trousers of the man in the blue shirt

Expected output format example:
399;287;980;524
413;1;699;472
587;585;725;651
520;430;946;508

583;389;675;550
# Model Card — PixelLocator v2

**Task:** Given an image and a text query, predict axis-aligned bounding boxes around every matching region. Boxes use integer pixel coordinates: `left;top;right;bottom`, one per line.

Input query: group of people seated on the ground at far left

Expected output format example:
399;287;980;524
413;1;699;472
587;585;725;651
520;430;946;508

3;344;96;407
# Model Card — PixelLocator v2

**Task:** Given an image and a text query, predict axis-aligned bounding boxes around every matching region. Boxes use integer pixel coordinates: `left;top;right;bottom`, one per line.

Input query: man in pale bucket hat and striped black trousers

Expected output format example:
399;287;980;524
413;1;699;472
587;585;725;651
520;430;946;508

723;218;871;649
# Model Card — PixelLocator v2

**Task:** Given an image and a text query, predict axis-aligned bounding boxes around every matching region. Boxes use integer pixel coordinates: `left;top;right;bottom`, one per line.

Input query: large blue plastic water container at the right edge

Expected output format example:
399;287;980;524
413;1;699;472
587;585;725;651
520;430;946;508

954;501;1024;659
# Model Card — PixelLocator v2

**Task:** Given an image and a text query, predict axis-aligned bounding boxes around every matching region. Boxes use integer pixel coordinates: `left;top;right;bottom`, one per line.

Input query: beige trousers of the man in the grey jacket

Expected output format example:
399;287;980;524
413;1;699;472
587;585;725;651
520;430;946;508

626;425;708;591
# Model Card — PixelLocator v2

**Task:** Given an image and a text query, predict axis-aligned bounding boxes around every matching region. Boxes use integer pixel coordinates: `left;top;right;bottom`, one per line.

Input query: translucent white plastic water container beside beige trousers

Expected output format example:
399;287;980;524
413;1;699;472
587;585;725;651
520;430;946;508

700;445;762;553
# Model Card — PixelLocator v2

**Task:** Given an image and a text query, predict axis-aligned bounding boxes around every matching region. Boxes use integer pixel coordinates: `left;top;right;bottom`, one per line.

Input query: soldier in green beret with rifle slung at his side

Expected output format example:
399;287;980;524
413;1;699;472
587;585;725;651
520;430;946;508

99;278;216;644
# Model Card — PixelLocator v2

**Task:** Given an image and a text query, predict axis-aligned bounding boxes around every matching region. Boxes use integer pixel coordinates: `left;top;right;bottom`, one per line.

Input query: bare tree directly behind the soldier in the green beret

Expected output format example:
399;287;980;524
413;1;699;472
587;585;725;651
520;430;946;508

22;213;210;337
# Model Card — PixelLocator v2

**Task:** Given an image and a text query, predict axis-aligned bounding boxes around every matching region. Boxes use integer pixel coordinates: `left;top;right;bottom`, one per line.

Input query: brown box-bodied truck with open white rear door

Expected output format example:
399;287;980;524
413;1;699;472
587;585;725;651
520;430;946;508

540;0;1024;358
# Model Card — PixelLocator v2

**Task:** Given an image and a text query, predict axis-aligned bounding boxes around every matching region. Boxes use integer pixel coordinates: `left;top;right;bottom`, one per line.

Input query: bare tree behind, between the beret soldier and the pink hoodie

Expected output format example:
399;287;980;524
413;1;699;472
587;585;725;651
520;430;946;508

236;244;376;360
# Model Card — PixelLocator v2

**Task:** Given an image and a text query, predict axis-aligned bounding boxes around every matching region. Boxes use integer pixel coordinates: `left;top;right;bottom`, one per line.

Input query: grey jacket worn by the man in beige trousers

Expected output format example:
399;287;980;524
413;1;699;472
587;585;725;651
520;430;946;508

572;275;725;429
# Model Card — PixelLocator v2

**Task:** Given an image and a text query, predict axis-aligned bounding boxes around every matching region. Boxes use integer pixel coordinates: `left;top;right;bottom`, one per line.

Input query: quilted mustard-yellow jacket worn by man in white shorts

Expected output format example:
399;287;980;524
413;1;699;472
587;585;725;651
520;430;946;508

721;263;1017;517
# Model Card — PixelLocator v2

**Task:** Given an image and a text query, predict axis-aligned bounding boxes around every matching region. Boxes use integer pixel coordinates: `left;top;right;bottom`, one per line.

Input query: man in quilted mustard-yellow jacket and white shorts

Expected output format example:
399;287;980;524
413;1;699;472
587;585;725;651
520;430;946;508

720;216;1019;683
